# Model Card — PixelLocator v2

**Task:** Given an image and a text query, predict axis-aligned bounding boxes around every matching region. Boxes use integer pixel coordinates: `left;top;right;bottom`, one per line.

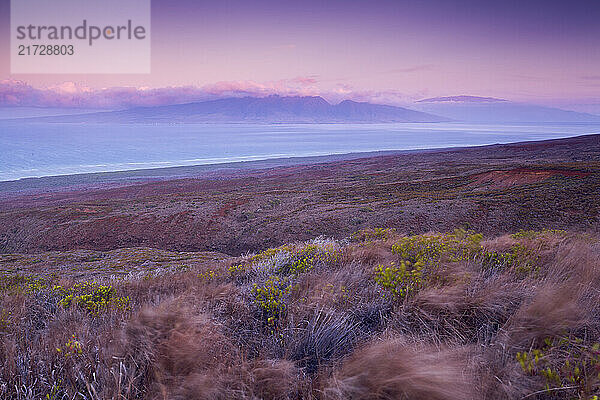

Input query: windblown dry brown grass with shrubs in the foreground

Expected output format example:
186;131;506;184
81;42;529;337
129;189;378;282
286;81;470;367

0;231;600;400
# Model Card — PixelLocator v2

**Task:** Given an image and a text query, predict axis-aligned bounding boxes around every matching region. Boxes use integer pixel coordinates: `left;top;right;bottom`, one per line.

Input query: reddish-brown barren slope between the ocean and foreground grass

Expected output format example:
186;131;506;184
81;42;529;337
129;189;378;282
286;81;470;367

0;135;600;254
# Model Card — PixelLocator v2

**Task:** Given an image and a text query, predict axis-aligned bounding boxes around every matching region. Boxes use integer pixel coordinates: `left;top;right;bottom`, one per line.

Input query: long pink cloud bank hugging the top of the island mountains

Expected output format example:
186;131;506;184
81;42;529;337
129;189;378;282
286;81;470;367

0;76;426;109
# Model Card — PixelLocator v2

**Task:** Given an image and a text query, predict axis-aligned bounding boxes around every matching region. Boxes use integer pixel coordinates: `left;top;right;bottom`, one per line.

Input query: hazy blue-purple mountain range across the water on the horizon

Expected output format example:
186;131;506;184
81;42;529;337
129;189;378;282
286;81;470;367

8;95;600;124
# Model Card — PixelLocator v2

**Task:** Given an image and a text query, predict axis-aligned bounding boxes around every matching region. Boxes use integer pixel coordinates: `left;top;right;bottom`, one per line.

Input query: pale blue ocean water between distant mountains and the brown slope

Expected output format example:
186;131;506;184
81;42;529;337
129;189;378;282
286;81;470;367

0;120;600;181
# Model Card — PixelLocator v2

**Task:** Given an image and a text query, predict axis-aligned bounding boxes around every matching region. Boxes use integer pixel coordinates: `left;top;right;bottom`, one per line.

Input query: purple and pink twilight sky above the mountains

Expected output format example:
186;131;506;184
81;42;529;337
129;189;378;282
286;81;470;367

0;0;600;105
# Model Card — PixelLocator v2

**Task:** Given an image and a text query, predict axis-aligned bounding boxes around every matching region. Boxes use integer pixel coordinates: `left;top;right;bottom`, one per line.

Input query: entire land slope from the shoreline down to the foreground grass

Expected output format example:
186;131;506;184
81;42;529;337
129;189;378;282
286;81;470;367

0;136;600;400
